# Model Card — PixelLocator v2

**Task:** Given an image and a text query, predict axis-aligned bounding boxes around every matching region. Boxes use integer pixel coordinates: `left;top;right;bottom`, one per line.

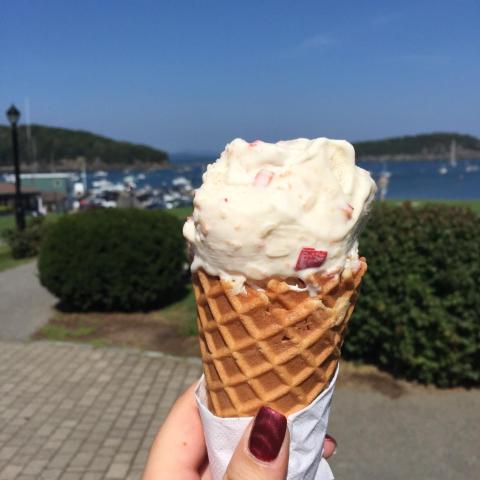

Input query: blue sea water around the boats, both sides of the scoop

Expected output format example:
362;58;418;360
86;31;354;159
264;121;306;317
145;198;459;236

91;160;480;200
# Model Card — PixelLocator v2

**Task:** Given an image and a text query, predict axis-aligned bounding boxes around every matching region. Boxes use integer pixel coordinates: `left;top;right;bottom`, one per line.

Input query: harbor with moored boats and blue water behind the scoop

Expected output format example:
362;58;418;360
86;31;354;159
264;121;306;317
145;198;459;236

0;159;480;214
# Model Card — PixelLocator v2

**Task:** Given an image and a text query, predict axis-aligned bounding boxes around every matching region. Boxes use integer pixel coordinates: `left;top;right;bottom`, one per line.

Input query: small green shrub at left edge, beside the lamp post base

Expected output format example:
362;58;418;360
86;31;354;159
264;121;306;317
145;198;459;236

4;217;46;258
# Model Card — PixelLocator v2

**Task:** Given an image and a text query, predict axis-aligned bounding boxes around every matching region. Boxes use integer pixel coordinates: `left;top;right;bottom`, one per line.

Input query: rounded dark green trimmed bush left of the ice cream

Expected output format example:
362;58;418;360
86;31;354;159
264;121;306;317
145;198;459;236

38;209;186;311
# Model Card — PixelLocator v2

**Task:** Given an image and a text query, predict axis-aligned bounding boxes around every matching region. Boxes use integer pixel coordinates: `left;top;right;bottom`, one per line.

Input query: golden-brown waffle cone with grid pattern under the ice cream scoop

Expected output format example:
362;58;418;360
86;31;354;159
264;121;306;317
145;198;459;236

193;258;367;417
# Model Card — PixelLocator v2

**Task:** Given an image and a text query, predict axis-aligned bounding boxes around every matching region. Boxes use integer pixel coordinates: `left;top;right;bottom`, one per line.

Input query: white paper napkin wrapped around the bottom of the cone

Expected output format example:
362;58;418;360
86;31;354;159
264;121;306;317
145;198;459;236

195;367;338;480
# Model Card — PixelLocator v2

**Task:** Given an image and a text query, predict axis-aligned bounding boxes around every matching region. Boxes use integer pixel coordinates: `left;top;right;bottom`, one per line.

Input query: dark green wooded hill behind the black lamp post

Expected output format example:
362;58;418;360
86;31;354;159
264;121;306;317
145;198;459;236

0;125;168;168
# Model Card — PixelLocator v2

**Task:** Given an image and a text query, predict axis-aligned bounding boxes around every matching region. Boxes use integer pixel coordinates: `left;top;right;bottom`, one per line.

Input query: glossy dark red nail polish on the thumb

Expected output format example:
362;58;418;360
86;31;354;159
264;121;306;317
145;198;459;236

248;407;287;462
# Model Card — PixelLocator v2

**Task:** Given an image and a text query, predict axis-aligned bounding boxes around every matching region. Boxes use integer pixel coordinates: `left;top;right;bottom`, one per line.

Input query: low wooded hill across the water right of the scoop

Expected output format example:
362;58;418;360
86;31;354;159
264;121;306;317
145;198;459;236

354;133;480;160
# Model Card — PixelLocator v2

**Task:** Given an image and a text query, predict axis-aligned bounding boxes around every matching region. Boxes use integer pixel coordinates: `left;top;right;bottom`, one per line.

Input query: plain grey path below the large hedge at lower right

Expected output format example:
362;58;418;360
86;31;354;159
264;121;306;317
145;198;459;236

329;372;480;480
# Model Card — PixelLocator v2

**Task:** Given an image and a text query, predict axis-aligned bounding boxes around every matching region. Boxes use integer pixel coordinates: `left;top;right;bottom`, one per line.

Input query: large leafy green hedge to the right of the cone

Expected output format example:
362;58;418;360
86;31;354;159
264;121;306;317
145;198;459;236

344;204;480;387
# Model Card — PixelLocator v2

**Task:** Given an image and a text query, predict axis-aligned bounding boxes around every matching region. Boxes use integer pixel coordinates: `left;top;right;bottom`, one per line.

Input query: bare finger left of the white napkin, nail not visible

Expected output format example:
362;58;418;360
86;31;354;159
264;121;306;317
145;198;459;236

143;384;207;480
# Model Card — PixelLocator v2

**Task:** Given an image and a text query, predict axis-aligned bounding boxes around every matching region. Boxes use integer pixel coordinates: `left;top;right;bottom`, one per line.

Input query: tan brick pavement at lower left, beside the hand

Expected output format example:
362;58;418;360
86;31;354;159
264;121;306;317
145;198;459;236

0;342;201;480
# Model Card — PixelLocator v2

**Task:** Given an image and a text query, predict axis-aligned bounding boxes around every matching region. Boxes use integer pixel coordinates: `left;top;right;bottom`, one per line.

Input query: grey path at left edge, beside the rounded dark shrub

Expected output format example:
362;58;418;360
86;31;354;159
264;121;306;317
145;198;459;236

0;261;57;340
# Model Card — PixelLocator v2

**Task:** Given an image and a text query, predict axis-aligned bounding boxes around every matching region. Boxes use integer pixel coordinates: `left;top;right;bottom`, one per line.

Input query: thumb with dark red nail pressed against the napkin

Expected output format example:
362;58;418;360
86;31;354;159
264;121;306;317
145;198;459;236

223;407;290;480
